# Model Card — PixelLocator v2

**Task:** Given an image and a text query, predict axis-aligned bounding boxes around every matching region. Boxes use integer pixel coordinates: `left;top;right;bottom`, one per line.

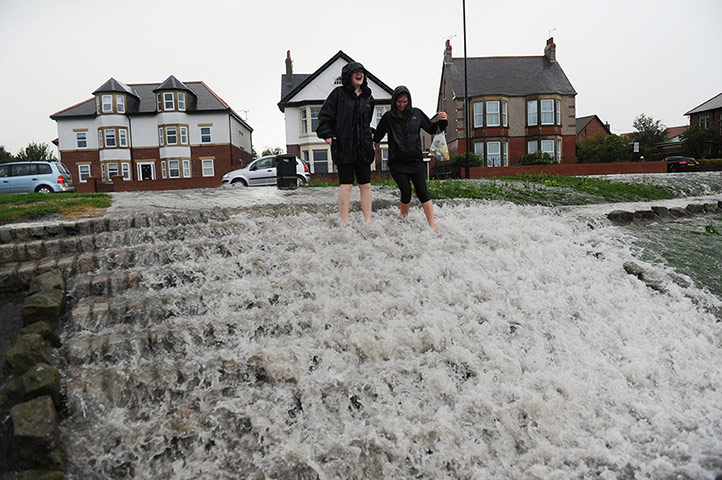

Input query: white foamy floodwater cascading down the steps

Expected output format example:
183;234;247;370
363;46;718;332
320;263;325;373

62;203;722;480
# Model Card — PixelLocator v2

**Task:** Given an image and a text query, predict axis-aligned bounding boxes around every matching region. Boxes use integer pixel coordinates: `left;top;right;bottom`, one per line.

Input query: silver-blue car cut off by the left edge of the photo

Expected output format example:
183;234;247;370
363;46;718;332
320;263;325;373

0;162;75;193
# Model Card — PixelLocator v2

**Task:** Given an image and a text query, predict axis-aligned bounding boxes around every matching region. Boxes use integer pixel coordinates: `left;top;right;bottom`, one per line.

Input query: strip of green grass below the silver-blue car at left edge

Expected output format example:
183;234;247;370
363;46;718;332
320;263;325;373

0;193;111;224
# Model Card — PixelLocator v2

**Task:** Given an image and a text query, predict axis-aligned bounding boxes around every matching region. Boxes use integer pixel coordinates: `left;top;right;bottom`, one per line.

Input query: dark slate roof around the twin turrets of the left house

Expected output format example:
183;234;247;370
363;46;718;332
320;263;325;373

50;80;253;131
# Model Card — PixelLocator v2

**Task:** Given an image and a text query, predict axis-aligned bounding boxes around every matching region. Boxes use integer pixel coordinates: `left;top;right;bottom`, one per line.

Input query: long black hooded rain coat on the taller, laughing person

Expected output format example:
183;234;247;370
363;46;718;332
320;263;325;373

316;62;375;164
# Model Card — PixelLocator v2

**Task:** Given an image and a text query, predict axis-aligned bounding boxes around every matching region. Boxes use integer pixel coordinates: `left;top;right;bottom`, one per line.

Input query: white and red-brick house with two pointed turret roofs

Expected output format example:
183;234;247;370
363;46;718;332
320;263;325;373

50;75;253;192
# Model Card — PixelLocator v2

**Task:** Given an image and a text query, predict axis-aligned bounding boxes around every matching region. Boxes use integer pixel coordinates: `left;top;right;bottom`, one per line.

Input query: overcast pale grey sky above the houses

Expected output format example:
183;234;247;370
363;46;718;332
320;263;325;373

0;0;722;154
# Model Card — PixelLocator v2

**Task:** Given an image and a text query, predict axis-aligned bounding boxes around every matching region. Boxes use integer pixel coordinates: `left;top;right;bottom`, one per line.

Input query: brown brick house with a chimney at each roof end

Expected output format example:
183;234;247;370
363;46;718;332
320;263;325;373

437;38;577;167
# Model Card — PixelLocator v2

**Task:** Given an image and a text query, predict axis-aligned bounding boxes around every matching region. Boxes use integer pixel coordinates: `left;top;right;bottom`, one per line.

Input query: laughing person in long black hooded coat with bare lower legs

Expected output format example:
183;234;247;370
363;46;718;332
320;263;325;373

316;62;374;225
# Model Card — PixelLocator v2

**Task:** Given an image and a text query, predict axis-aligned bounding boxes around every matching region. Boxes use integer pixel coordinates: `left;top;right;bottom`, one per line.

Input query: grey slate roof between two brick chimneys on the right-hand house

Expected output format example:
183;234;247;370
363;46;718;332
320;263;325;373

444;56;577;98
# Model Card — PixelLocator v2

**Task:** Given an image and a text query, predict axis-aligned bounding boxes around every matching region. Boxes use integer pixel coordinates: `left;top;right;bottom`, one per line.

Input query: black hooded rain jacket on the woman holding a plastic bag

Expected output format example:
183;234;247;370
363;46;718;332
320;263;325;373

374;85;448;168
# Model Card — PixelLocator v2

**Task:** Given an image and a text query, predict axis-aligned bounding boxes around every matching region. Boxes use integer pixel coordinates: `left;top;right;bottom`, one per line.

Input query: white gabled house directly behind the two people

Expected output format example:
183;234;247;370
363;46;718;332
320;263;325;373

278;50;393;174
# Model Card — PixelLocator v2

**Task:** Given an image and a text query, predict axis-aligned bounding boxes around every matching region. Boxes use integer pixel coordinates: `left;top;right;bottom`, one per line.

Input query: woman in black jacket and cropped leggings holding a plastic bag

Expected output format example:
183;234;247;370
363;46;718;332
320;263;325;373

374;85;448;234
